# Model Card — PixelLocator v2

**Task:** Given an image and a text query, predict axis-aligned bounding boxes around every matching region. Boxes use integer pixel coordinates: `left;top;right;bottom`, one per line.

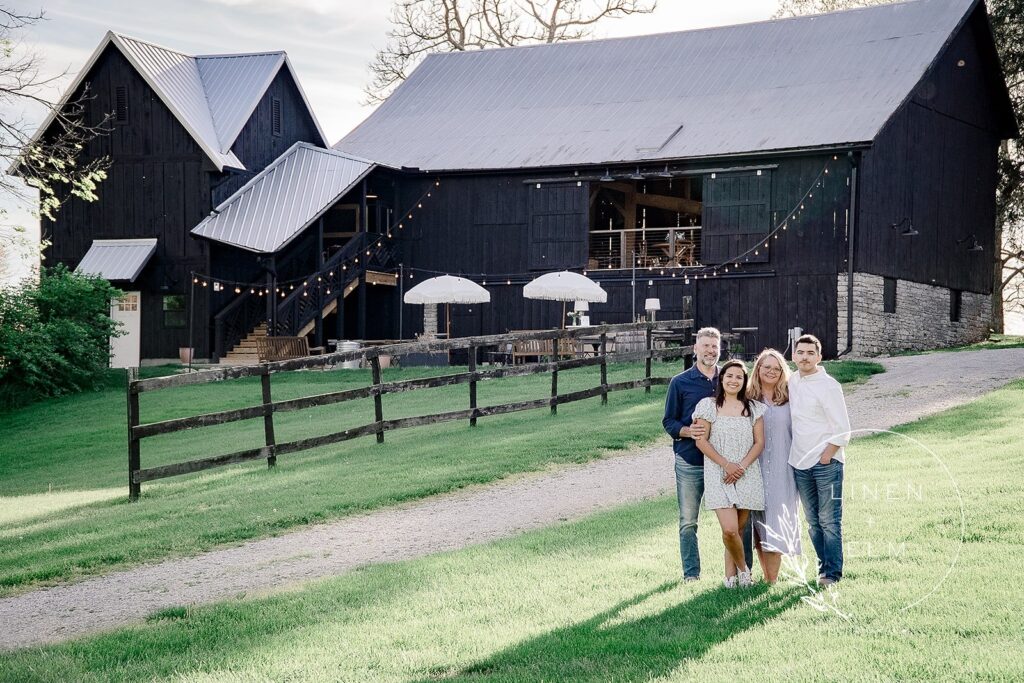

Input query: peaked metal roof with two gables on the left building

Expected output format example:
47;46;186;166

18;31;327;171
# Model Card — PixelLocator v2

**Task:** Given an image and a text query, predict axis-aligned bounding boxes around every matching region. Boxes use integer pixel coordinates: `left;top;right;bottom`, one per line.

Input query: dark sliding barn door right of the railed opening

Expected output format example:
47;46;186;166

700;170;771;264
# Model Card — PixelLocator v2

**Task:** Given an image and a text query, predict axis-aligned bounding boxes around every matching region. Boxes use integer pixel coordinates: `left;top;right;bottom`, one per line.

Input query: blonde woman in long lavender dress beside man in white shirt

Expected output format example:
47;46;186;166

748;348;801;584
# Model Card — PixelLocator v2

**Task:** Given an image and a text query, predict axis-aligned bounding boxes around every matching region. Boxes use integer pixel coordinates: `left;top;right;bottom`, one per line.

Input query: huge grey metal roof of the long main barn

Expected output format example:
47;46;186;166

335;0;977;170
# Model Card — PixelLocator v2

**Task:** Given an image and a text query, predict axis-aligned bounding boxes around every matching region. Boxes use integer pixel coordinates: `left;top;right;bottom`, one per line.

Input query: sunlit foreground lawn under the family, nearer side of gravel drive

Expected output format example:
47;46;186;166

0;382;1024;682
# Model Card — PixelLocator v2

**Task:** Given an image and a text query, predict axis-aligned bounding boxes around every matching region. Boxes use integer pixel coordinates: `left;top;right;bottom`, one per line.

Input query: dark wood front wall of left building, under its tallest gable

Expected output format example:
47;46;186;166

42;46;213;358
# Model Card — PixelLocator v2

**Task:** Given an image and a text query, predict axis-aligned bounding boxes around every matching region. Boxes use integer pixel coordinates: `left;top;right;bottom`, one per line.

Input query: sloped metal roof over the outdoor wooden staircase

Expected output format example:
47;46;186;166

191;142;376;254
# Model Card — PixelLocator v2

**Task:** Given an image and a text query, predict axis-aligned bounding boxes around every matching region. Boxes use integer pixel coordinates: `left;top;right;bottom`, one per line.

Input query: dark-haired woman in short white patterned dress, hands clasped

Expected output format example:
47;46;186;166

693;360;765;588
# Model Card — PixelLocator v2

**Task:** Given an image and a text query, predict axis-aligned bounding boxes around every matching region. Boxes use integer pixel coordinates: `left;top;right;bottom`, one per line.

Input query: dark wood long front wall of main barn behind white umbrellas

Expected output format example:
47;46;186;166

387;155;850;355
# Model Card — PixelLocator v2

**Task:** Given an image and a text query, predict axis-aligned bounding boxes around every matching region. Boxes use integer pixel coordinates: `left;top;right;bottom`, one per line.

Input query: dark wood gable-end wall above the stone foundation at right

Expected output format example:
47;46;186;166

855;8;1008;293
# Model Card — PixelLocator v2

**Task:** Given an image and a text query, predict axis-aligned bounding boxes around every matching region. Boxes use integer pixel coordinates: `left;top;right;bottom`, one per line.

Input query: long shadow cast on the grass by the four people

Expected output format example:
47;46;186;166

422;582;800;683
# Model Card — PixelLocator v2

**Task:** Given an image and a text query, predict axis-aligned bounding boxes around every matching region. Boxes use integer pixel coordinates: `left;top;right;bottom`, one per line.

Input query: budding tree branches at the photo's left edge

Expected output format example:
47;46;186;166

0;7;110;225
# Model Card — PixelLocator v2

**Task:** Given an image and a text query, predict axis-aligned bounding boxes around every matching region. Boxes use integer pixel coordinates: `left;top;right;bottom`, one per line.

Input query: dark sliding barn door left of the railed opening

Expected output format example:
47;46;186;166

528;182;590;270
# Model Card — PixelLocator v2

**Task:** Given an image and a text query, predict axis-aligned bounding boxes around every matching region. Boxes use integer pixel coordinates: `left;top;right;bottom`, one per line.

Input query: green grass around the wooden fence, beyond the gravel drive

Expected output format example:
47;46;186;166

0;361;874;595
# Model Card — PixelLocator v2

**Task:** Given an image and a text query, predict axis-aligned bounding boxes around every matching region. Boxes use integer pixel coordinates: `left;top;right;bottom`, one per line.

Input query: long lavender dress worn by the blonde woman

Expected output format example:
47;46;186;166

751;403;801;555
